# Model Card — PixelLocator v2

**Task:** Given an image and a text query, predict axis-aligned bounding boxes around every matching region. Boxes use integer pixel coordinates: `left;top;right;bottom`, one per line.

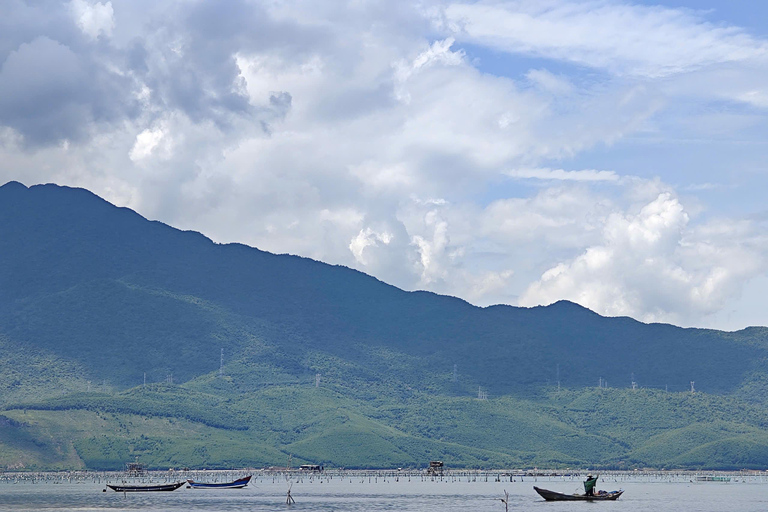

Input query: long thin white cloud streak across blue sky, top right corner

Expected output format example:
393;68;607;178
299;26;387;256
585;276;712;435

435;0;768;77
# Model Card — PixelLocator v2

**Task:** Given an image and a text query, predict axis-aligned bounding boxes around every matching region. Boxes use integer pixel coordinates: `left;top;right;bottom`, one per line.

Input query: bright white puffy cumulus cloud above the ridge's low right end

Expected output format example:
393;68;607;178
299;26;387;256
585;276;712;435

520;193;765;322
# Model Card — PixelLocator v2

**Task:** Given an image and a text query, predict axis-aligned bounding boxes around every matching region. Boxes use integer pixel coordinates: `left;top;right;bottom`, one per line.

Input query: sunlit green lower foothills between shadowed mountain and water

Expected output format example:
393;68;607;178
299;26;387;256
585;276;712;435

0;385;768;469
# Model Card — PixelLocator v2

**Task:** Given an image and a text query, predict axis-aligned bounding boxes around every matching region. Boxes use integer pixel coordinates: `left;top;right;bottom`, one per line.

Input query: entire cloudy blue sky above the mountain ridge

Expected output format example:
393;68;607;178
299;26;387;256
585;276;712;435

0;0;768;330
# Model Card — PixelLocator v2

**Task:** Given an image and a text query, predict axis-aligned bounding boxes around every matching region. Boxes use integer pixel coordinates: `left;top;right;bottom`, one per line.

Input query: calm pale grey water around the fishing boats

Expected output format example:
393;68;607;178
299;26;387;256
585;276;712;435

0;476;768;512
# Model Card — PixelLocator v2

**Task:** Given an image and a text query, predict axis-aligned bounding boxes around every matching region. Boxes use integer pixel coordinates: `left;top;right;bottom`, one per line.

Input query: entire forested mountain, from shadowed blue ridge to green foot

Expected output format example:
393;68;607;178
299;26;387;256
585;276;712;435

0;183;768;469
